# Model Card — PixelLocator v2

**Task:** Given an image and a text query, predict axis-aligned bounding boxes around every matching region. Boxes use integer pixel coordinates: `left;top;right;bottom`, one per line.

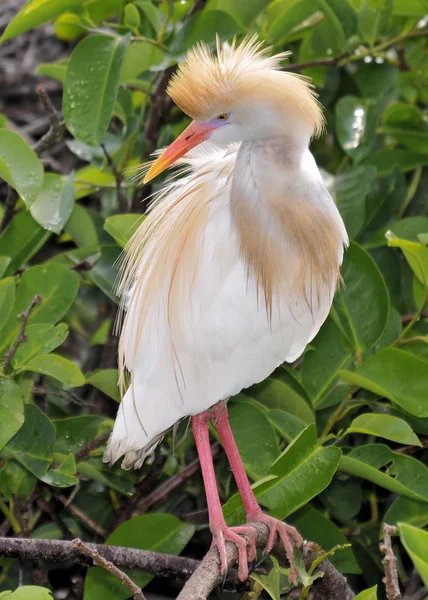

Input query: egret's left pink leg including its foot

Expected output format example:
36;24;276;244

192;411;256;581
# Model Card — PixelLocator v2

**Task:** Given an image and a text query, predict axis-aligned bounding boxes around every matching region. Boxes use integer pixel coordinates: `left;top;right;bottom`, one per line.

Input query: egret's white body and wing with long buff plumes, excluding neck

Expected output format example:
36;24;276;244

106;144;346;467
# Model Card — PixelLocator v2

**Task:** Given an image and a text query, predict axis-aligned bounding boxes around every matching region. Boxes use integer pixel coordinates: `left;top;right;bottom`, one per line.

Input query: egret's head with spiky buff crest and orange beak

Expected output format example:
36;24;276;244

144;37;324;183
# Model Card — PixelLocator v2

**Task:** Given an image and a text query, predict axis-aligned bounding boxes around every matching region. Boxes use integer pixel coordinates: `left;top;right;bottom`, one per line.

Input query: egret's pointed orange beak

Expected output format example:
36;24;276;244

143;121;215;183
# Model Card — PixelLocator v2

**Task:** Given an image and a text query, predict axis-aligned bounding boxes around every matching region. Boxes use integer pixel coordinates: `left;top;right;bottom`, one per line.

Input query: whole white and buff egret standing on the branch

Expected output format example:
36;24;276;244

105;38;348;580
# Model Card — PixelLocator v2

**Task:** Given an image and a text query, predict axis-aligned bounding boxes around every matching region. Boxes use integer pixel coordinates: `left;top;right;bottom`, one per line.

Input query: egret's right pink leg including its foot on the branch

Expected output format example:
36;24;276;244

212;402;303;582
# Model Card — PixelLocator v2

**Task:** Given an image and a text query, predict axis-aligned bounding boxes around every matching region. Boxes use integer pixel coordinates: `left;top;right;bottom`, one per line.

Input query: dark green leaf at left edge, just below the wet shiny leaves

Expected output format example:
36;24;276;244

0;211;50;275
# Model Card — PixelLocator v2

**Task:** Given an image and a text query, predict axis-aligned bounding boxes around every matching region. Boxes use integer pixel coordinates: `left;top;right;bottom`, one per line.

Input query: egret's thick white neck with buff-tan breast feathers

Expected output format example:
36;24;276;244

230;136;346;311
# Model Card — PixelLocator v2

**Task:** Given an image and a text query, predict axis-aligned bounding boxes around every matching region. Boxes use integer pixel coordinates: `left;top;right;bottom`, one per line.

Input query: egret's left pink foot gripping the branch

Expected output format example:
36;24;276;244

211;525;257;581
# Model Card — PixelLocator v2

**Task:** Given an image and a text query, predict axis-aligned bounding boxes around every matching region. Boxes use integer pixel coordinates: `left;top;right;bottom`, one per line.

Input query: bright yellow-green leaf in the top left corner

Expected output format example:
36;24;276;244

0;0;84;43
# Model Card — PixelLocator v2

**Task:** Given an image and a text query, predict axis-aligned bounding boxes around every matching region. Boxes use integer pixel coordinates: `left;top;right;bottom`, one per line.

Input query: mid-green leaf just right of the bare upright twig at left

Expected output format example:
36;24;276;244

12;323;68;369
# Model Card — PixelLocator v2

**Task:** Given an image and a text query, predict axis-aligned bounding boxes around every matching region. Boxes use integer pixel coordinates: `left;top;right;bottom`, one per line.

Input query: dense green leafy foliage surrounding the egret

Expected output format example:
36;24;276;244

0;0;428;600
